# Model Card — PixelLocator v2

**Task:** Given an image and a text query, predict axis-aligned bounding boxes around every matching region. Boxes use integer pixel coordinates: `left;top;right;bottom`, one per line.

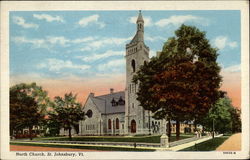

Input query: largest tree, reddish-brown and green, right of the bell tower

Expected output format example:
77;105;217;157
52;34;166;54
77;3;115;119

134;25;222;138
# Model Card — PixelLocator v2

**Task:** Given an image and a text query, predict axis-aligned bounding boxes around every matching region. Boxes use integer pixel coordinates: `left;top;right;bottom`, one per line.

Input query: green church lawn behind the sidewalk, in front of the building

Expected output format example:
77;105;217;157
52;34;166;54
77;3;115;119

34;134;193;143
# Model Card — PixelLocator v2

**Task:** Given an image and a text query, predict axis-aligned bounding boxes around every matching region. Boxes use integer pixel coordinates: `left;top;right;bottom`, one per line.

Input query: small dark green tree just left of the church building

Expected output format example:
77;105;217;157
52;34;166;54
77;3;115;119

49;93;84;140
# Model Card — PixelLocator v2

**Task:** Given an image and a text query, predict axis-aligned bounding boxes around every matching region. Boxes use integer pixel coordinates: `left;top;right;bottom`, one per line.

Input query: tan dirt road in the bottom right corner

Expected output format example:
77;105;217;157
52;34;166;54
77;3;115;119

216;133;241;151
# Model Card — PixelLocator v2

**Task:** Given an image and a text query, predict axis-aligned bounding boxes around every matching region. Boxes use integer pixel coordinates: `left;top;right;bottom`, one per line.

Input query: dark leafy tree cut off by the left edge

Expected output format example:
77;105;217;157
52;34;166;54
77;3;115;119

10;84;44;139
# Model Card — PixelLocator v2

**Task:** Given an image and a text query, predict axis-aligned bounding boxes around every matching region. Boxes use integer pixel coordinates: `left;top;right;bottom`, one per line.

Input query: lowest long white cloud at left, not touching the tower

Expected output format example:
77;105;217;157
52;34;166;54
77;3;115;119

37;58;90;71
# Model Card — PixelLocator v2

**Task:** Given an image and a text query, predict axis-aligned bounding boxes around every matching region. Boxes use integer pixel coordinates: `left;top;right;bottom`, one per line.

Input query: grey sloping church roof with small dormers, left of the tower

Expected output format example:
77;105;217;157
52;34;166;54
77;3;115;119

91;91;125;114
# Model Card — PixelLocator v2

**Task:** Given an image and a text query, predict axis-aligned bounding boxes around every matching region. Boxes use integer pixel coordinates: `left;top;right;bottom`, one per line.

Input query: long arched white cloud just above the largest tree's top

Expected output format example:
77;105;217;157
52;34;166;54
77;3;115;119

155;15;208;27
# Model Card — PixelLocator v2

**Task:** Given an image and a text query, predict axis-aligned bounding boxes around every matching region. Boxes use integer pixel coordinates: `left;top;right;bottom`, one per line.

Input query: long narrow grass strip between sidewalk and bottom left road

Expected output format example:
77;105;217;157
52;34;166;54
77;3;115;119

10;142;155;152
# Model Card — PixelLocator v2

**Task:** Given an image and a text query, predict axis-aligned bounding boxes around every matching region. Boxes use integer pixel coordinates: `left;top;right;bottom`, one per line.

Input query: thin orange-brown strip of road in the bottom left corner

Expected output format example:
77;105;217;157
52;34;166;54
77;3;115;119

10;145;100;152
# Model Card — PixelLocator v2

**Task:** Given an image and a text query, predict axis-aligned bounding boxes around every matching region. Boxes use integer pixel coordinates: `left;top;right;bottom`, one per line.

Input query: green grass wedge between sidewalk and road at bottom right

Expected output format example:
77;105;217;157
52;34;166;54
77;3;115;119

180;136;229;151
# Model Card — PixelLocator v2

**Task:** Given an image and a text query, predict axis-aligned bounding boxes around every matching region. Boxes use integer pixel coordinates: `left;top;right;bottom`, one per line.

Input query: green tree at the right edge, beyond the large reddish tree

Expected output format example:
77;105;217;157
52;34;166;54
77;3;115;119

201;97;241;133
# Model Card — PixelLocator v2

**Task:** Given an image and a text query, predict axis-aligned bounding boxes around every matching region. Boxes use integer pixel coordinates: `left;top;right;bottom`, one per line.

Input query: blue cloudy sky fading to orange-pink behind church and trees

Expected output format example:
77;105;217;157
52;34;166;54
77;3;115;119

9;10;241;108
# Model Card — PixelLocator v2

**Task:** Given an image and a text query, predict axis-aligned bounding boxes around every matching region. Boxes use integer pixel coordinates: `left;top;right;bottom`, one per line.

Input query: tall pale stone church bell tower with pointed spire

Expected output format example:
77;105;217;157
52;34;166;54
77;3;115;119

124;11;149;134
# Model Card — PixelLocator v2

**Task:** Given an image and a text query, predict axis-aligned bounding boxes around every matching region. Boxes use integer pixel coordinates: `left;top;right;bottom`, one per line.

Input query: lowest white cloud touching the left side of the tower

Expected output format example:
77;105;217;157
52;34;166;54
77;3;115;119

97;59;125;71
